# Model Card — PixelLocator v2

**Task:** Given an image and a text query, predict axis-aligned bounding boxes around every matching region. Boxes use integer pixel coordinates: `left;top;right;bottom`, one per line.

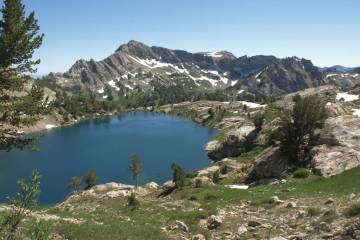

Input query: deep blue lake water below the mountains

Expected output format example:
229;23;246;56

0;112;216;205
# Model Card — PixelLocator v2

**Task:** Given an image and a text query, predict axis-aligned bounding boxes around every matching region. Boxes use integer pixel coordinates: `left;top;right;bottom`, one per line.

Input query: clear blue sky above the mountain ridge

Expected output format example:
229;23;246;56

20;0;360;74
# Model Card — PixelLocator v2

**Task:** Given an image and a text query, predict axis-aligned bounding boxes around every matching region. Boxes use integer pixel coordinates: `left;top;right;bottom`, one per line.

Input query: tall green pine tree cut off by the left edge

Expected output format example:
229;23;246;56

0;0;48;150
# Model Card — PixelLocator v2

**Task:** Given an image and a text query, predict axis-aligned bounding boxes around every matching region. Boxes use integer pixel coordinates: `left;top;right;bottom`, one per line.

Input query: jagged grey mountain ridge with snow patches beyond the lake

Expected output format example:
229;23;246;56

46;41;338;96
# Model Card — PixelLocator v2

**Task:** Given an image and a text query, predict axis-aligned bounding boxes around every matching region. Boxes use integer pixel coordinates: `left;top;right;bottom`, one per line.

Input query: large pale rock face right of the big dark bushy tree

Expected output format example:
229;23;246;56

312;115;360;177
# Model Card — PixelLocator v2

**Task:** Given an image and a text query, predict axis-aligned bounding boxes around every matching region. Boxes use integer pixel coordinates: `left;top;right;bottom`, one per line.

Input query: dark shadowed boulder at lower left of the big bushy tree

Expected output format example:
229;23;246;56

254;148;288;178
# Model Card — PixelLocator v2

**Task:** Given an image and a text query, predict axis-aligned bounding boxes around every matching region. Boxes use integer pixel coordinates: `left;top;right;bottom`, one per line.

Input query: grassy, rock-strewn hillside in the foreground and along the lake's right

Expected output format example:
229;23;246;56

0;86;360;240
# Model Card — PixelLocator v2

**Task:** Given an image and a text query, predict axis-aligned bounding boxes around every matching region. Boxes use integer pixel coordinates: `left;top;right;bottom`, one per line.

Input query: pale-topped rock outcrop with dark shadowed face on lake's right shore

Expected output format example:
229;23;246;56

205;126;257;160
